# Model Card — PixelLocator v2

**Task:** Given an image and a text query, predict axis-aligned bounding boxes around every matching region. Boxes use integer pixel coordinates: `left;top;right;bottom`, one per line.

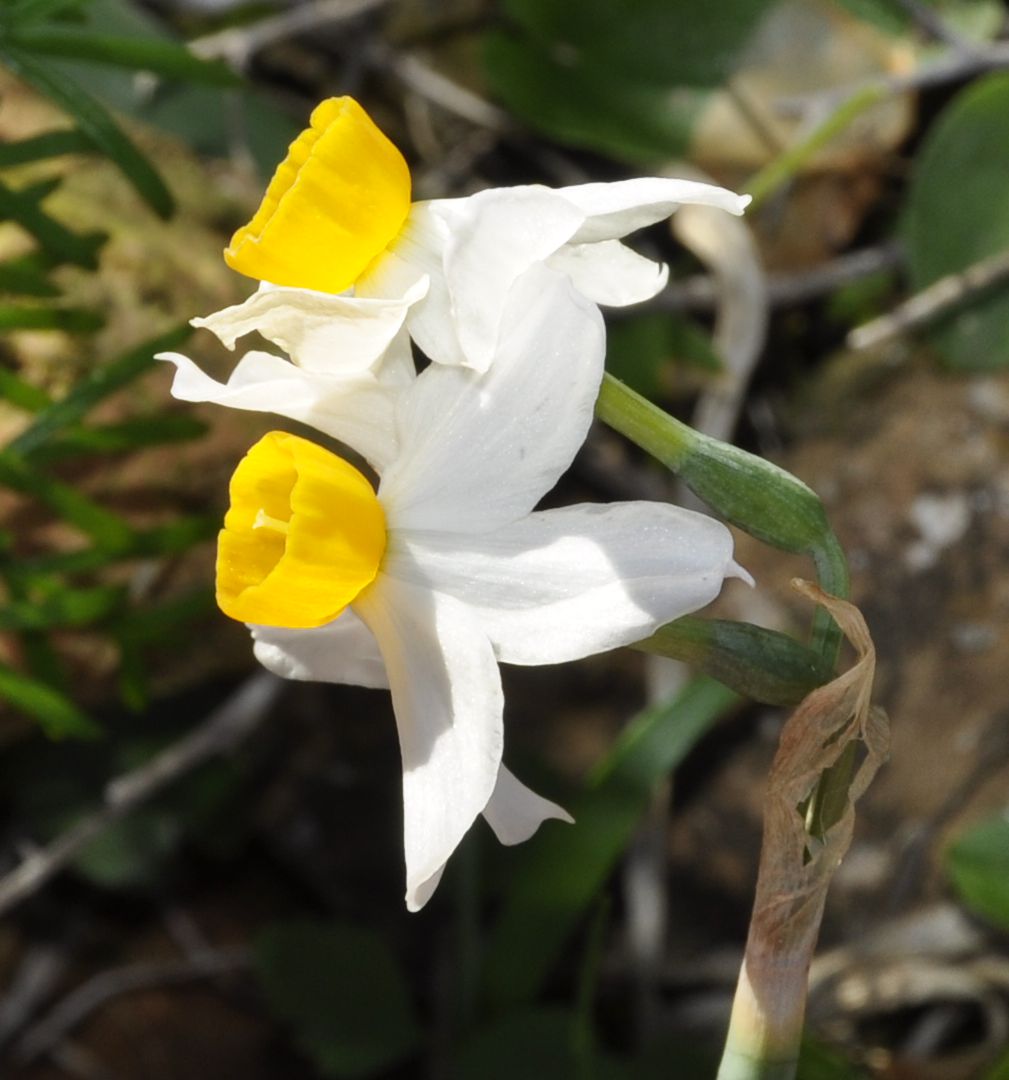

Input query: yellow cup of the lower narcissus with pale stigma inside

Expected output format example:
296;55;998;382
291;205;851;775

217;431;386;629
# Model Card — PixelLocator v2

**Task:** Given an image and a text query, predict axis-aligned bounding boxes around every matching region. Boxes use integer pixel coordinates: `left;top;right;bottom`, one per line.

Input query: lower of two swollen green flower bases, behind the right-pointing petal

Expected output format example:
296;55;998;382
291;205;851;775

634;616;830;705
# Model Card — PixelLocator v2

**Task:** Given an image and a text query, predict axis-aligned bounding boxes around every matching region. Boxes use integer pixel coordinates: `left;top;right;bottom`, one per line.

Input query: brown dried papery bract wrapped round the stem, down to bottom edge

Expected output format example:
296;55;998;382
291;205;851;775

718;580;889;1080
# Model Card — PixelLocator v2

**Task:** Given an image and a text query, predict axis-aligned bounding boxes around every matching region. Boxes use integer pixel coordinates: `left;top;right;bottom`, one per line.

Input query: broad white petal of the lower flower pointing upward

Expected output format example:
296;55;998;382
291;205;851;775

379;267;605;531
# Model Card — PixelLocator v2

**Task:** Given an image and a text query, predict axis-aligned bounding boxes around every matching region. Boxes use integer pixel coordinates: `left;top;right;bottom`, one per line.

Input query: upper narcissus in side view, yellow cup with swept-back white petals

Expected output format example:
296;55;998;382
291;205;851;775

225;97;749;370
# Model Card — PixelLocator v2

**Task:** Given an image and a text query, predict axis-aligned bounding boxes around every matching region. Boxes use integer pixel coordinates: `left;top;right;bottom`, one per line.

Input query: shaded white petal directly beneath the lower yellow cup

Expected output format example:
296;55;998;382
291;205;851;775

248;609;389;689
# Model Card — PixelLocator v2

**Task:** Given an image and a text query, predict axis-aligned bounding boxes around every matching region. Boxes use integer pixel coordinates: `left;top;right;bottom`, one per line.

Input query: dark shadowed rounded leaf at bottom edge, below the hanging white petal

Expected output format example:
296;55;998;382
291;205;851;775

255;922;421;1077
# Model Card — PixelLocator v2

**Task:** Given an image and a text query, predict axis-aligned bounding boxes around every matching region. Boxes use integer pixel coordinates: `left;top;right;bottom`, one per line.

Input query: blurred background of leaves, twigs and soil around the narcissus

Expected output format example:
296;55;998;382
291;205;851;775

0;0;1009;1080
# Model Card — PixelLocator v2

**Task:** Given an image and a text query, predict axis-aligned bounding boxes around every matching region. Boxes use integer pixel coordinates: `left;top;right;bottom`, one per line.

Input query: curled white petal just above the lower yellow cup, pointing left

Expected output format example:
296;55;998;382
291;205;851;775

157;351;396;470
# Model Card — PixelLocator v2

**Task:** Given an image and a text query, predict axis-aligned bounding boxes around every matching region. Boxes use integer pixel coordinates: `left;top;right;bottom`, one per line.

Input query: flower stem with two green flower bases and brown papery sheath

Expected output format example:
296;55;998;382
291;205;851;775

596;375;886;1080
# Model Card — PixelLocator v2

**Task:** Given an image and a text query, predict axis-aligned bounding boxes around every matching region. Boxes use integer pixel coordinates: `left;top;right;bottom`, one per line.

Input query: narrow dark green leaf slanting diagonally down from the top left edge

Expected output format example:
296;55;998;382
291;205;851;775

0;40;175;218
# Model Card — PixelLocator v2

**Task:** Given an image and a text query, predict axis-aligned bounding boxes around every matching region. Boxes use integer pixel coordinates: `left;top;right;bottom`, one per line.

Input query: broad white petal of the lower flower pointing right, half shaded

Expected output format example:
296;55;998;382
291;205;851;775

386;502;745;664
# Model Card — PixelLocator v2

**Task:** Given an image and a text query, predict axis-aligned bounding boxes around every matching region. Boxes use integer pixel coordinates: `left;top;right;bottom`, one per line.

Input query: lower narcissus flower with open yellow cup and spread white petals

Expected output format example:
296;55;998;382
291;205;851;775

197;267;744;909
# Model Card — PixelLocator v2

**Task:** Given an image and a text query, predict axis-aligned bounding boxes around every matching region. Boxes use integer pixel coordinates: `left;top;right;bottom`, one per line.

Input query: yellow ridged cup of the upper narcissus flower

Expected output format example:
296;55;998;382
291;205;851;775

225;97;411;293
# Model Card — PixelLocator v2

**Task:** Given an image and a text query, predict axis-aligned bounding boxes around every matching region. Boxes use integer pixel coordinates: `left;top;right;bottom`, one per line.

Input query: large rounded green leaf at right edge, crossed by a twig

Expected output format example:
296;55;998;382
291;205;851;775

904;75;1009;370
